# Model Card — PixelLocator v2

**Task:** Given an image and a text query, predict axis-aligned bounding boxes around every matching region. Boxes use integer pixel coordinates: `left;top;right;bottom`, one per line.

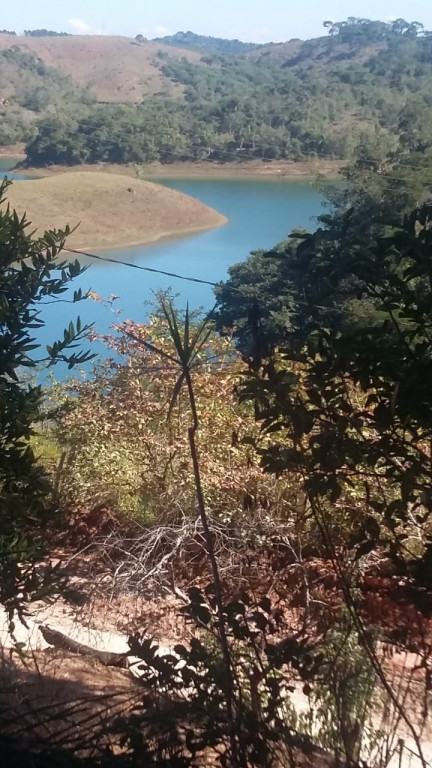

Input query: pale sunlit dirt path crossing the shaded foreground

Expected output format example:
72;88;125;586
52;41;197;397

0;600;432;768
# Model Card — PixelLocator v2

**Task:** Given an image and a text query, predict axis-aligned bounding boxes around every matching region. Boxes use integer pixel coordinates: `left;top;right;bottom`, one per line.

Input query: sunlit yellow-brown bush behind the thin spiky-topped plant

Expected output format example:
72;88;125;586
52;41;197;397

55;314;306;583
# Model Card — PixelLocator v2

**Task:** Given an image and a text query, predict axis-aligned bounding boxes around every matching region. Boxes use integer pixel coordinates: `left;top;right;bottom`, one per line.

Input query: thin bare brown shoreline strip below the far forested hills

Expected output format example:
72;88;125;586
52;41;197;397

7;154;343;181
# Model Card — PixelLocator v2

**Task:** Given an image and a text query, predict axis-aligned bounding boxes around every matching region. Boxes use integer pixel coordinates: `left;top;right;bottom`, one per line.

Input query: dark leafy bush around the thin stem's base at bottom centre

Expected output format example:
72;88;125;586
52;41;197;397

114;584;320;768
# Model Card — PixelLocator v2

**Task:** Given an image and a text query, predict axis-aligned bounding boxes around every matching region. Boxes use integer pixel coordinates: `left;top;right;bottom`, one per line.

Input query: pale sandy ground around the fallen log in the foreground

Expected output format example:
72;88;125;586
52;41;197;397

0;600;432;768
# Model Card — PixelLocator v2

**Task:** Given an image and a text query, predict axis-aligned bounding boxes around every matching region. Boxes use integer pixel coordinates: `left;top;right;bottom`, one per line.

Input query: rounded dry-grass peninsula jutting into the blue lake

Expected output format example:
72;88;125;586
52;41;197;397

8;172;227;249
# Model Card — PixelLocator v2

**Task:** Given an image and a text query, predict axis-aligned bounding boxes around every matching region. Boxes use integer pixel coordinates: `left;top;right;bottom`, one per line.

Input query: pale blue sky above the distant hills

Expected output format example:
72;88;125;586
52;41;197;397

0;0;432;42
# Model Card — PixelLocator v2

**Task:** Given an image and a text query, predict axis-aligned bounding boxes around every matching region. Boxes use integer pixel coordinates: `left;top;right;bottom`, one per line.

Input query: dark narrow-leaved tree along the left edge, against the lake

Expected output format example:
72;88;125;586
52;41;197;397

0;180;92;615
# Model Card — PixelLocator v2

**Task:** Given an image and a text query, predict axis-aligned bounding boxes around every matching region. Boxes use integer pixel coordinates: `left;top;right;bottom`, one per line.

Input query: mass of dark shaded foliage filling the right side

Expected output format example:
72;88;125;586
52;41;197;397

201;160;432;764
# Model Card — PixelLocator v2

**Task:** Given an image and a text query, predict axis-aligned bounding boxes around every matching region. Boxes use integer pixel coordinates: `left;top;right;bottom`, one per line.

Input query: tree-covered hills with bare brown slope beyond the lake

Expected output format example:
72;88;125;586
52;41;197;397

0;19;432;165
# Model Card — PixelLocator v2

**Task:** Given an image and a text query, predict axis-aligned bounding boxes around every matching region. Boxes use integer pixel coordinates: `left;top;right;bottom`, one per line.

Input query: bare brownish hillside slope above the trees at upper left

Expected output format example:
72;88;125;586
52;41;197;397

0;35;201;103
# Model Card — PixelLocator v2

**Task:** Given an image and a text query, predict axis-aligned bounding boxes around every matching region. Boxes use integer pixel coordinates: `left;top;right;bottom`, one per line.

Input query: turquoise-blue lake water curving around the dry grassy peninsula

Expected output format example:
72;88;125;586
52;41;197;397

0;158;323;364
